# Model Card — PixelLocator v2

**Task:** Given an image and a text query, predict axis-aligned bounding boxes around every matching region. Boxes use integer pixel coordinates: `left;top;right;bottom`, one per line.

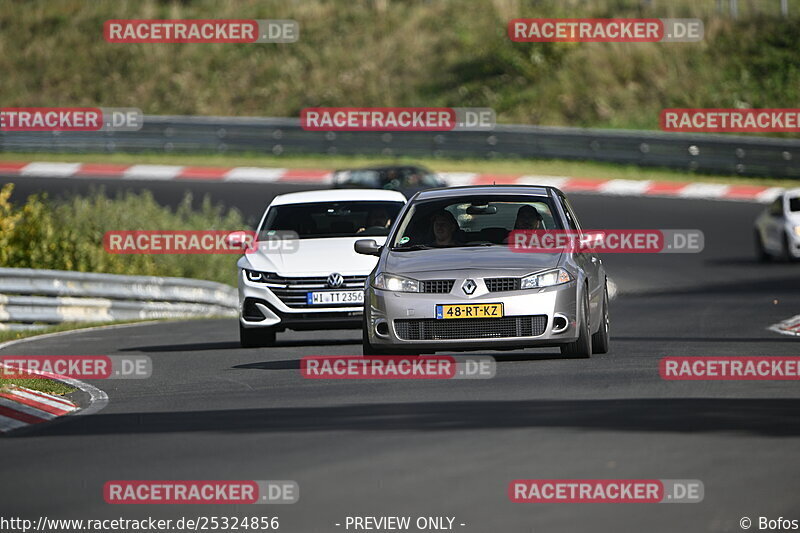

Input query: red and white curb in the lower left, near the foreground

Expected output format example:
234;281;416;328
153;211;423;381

0;385;78;433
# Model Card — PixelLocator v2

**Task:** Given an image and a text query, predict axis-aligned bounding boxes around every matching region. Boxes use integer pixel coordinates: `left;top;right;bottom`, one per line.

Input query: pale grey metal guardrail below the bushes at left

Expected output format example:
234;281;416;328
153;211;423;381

0;268;238;329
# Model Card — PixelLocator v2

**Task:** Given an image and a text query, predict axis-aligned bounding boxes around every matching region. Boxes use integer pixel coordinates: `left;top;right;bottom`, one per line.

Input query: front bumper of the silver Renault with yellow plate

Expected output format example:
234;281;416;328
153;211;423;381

366;280;582;351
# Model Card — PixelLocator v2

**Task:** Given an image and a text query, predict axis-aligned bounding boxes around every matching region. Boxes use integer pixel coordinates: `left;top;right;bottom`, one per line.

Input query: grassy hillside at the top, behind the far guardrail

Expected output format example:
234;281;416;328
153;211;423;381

0;0;800;129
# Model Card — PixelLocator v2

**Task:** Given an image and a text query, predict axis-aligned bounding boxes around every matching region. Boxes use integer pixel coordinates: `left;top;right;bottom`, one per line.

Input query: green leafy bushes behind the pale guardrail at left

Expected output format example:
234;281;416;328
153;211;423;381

0;184;246;285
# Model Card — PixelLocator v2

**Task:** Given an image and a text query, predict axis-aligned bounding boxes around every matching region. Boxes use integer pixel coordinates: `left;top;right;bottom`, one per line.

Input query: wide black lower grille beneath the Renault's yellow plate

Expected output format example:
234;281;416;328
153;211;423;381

394;315;547;341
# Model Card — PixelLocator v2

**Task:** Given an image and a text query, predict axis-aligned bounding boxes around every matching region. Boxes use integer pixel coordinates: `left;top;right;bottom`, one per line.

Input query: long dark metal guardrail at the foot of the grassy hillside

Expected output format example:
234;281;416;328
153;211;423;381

0;116;800;178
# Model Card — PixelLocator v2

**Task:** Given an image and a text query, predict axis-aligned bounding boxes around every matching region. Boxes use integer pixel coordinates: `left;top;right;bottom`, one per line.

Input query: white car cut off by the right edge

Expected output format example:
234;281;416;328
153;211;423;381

755;189;800;261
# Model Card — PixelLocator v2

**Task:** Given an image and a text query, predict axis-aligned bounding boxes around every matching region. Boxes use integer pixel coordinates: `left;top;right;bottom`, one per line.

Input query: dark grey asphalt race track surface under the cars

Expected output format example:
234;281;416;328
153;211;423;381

0;176;800;533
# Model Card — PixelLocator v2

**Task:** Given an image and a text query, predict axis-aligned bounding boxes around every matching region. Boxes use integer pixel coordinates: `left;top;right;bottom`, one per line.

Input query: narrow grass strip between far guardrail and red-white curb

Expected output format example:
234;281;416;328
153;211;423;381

0;152;797;187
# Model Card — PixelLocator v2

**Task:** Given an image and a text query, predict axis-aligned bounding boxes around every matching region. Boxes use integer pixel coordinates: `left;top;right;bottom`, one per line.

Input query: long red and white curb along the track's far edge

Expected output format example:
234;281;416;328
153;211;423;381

0;161;782;203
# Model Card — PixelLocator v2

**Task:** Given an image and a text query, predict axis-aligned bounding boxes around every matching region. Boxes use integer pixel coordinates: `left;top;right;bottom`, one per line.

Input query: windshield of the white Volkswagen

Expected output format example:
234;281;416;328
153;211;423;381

258;201;403;241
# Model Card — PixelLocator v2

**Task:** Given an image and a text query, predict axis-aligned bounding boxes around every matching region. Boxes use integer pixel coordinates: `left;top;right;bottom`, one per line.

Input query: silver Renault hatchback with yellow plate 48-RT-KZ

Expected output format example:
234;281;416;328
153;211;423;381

354;185;609;357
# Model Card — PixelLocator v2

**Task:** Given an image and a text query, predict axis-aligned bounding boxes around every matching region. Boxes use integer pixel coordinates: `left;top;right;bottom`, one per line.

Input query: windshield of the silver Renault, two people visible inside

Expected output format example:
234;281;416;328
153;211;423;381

392;195;562;250
